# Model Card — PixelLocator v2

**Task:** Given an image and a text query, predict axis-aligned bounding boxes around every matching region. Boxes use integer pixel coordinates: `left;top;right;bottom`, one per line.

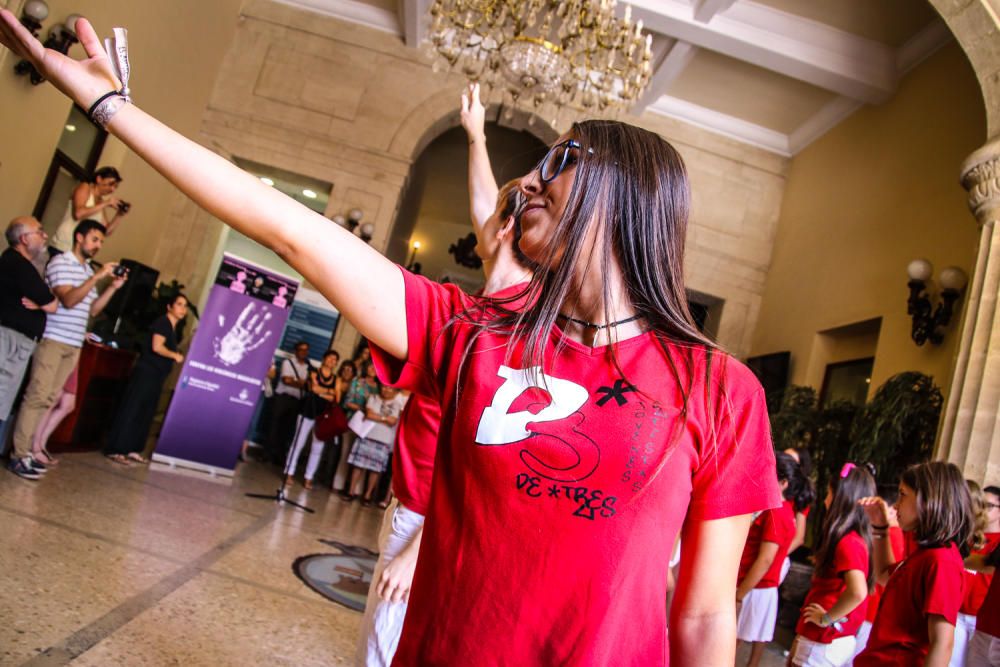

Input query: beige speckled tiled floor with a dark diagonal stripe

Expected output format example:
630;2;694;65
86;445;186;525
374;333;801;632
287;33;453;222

0;453;784;667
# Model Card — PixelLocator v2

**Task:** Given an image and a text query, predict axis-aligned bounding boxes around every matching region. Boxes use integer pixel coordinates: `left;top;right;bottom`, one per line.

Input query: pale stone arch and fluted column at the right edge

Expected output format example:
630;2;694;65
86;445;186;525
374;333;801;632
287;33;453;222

930;0;1000;484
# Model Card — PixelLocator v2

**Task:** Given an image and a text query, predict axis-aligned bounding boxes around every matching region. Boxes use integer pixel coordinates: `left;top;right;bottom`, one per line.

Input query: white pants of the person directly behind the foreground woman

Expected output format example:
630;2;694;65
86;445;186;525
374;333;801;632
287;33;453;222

354;498;424;667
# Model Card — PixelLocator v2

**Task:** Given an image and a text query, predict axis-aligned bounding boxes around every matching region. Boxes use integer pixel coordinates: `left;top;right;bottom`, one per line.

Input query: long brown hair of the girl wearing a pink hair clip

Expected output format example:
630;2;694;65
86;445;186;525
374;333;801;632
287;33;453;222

815;466;876;590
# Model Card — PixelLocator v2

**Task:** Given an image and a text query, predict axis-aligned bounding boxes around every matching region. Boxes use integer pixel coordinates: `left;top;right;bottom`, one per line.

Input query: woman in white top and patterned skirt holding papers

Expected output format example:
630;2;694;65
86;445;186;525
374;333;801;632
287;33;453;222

344;385;406;506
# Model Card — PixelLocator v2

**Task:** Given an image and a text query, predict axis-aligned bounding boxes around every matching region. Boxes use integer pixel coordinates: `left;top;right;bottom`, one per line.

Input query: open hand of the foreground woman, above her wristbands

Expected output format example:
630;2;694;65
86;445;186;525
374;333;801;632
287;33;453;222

0;9;121;109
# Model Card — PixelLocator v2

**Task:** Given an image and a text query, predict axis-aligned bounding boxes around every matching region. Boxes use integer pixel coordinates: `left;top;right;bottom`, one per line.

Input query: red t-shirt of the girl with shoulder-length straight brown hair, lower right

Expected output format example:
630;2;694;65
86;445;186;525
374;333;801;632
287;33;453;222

854;544;965;667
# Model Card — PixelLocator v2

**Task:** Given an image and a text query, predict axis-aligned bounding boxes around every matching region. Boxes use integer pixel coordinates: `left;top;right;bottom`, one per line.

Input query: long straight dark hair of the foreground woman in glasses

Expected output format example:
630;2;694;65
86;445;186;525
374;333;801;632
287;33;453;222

456;120;735;492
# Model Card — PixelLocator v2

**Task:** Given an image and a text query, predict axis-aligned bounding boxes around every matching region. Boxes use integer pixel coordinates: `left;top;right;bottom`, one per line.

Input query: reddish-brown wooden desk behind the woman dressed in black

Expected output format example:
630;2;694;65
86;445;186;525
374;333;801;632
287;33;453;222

48;342;136;452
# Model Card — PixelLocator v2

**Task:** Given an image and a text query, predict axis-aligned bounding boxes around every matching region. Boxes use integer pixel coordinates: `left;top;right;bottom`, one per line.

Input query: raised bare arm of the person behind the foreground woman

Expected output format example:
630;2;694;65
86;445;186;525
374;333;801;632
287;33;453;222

461;83;500;248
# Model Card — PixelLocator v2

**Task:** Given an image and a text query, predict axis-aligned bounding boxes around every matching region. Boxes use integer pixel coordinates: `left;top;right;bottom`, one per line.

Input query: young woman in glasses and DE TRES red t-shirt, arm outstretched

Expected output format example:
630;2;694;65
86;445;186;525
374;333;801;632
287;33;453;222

0;18;781;667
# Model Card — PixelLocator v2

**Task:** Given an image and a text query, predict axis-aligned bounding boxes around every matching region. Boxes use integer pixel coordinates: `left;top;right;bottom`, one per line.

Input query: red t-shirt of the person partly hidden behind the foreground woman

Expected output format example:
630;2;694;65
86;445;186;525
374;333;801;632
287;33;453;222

392;393;441;514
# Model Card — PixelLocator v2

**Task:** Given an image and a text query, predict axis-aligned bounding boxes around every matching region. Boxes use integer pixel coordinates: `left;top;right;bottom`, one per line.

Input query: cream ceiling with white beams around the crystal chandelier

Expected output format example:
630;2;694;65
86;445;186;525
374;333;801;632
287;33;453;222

272;0;951;156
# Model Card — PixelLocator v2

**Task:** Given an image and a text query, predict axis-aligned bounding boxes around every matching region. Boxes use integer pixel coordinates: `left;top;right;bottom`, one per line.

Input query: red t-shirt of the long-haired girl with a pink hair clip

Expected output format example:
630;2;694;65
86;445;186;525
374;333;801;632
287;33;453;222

795;532;868;644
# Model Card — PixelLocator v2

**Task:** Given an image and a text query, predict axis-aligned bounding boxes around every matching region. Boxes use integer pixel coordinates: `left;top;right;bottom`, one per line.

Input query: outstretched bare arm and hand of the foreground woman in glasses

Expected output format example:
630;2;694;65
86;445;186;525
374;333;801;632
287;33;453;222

0;10;407;358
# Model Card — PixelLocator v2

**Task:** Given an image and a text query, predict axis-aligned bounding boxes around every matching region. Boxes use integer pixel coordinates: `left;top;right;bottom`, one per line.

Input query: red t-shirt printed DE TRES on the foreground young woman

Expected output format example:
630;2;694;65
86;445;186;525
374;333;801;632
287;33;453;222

372;271;781;665
